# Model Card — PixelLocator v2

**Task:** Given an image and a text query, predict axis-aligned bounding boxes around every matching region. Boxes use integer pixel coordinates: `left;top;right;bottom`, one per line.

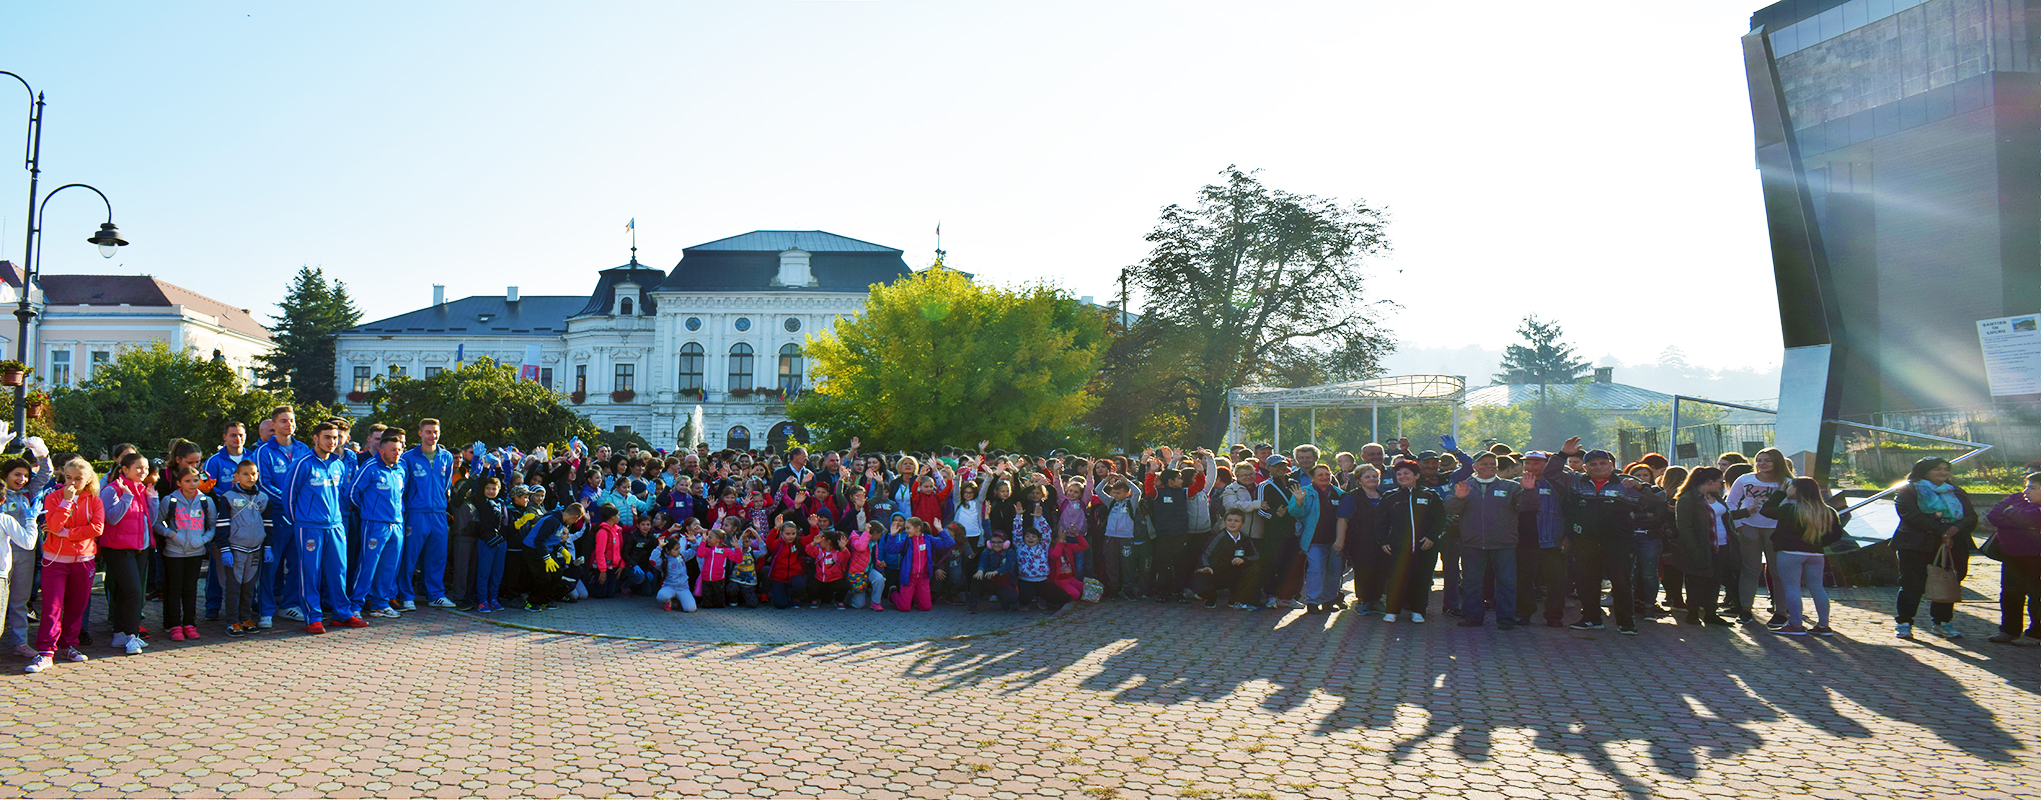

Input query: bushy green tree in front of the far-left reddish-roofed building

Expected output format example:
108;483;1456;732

51;341;339;457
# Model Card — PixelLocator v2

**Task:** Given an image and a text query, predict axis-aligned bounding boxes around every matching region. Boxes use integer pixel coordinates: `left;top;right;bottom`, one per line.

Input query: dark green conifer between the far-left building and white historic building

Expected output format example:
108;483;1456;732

255;267;361;404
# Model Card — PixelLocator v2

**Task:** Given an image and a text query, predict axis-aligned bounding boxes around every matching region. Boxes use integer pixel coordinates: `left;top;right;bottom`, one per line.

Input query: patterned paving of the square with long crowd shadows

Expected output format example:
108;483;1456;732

0;561;2041;798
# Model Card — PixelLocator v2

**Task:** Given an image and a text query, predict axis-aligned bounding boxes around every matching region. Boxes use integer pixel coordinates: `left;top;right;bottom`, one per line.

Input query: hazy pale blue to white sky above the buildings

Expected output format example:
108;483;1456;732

0;0;1780;367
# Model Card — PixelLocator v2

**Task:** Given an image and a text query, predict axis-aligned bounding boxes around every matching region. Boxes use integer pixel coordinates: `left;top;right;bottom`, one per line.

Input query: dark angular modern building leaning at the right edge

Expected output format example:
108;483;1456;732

1743;0;2041;424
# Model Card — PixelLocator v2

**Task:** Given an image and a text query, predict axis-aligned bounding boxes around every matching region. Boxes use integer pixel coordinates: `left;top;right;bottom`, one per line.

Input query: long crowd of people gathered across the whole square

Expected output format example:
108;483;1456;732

0;406;2041;671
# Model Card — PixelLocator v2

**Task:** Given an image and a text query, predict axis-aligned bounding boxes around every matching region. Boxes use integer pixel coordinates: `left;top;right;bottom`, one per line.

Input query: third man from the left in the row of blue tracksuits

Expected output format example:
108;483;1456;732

284;422;367;633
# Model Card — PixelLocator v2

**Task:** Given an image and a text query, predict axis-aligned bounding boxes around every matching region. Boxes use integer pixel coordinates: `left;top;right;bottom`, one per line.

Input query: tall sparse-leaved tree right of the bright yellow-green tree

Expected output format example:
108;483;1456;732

1116;167;1394;445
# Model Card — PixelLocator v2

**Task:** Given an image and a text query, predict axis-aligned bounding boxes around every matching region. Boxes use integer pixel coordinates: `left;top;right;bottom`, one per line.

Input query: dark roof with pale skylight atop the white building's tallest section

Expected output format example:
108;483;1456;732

659;231;912;292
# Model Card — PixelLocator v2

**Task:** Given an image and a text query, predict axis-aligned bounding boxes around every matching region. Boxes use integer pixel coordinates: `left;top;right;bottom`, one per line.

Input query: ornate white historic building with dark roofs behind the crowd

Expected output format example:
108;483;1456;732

337;231;910;449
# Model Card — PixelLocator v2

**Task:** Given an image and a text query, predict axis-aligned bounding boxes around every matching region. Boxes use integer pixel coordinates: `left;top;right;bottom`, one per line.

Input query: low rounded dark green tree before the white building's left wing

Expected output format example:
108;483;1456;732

369;357;602;451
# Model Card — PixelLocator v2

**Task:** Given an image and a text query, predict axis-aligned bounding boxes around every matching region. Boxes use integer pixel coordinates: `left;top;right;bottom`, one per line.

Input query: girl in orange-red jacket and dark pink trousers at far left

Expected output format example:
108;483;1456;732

27;459;106;671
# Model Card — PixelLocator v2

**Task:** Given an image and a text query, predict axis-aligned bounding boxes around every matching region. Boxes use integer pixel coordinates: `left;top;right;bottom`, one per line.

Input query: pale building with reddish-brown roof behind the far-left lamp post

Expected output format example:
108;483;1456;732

0;261;276;386
